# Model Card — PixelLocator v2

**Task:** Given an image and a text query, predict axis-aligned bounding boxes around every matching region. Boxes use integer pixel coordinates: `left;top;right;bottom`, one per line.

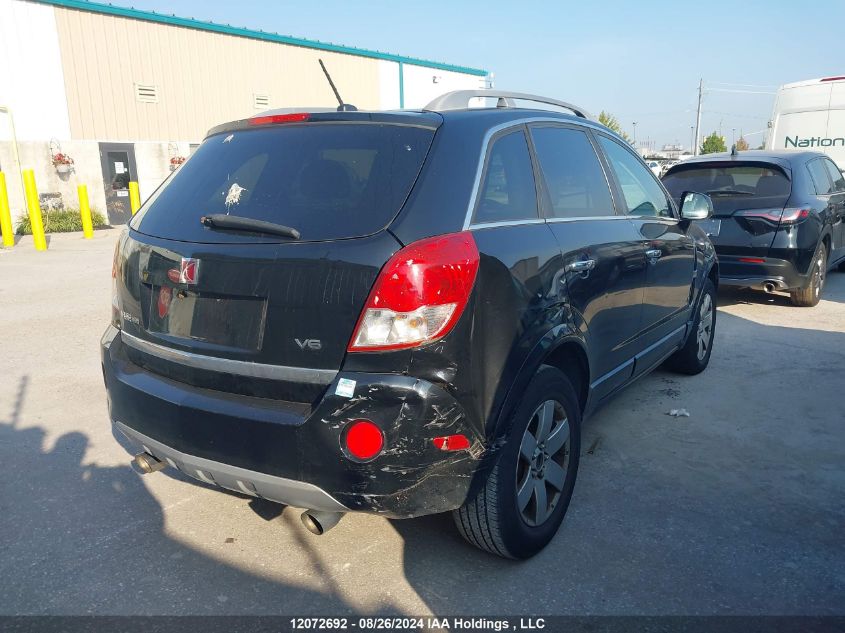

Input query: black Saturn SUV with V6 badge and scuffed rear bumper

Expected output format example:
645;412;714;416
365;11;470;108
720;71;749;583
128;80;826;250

102;91;718;558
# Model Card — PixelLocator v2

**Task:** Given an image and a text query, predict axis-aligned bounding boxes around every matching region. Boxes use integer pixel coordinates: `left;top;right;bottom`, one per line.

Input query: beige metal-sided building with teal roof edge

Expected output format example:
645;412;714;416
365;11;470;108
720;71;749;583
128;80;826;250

0;0;487;223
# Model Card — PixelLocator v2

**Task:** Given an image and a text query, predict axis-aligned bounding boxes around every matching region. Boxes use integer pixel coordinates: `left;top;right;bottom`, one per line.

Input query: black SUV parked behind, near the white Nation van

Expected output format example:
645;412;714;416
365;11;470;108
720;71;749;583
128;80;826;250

663;151;845;306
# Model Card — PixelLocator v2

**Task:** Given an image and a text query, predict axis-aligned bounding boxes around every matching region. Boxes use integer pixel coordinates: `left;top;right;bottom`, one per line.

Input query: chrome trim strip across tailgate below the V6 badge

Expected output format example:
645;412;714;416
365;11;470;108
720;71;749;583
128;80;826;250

120;332;337;385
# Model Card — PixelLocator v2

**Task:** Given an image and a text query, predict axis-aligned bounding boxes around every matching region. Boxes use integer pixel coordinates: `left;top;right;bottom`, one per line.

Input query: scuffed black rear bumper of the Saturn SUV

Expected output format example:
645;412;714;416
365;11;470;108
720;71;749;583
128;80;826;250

101;328;485;518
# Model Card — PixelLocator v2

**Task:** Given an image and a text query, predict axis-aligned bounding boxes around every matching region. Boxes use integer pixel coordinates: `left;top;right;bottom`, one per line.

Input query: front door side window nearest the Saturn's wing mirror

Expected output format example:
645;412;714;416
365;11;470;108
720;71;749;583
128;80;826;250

599;135;674;218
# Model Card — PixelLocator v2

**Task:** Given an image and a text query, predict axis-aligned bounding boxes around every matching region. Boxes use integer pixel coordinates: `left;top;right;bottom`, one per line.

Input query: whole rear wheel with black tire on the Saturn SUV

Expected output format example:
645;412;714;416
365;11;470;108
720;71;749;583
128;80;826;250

453;365;581;559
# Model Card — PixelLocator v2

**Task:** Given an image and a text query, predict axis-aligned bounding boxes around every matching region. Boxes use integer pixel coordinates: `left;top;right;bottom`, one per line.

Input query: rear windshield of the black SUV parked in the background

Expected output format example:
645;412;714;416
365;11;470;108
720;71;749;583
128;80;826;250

663;164;792;211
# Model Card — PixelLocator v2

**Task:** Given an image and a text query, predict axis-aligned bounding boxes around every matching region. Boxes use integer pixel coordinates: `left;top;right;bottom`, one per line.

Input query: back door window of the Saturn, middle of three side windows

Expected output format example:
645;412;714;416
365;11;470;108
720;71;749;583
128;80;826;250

531;126;614;218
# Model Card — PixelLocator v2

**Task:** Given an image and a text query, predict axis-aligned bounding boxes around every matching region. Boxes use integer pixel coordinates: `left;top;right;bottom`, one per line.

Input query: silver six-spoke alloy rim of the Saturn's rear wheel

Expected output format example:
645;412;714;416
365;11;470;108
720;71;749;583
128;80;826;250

516;400;570;527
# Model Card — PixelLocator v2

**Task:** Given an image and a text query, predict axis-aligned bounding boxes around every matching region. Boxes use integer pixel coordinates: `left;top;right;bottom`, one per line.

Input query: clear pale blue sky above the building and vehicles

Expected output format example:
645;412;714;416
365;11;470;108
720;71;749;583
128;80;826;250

117;0;845;149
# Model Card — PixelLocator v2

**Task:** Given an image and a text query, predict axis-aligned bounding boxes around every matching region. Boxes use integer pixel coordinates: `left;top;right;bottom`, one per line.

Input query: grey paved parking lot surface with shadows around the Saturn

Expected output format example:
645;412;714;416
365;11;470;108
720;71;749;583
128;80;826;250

0;230;845;616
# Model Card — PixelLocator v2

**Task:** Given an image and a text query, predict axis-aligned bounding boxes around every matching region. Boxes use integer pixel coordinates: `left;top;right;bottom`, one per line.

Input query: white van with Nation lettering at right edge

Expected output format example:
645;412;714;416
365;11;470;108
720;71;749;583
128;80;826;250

766;75;845;170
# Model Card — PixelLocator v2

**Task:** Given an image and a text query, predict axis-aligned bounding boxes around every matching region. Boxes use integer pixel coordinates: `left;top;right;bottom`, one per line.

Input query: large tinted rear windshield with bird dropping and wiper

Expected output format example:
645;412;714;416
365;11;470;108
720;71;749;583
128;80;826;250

131;123;434;242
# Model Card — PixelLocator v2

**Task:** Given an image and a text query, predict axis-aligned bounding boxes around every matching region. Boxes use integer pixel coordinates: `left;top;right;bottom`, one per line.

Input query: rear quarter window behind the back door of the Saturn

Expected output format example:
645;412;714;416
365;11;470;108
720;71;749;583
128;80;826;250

473;128;538;224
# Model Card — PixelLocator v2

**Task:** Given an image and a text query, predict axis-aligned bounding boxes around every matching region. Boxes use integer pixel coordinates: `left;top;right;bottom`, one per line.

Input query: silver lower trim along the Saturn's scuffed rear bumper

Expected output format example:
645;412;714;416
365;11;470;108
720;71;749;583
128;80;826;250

114;421;349;512
